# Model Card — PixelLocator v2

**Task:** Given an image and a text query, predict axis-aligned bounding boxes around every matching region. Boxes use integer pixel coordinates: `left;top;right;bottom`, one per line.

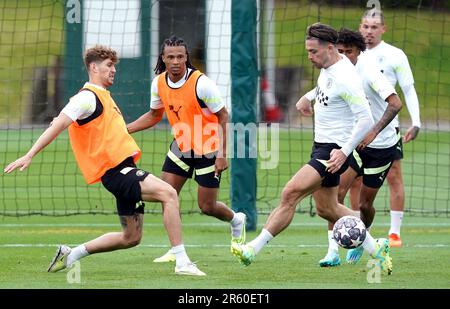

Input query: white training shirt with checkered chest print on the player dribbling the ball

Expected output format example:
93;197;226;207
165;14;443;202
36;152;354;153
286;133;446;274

314;55;373;156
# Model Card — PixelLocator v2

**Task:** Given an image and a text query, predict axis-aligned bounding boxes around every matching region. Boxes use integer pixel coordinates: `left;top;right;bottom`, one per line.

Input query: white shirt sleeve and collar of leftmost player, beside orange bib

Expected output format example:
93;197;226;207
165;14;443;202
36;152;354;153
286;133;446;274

61;83;105;121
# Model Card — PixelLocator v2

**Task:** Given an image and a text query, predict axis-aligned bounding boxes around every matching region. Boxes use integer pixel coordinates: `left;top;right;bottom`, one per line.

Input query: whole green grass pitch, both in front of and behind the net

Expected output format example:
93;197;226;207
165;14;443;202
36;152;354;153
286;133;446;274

0;130;450;289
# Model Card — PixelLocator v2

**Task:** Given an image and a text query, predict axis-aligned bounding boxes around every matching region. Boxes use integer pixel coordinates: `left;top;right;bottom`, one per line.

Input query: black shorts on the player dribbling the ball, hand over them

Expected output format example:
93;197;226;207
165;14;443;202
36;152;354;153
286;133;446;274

308;142;348;188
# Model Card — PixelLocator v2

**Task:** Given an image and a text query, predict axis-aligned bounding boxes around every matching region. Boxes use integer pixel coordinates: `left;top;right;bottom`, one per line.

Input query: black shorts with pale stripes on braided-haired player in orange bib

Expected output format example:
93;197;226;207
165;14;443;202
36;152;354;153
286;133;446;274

162;140;220;188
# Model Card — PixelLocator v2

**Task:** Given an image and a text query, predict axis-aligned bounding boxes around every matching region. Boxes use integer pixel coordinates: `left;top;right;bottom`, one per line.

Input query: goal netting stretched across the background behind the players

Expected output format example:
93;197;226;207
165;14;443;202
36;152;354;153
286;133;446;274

0;0;450;216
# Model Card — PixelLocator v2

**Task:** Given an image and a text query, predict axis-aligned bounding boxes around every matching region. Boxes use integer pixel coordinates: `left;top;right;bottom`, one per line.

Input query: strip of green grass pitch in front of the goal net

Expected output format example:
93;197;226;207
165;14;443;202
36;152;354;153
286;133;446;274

0;214;450;289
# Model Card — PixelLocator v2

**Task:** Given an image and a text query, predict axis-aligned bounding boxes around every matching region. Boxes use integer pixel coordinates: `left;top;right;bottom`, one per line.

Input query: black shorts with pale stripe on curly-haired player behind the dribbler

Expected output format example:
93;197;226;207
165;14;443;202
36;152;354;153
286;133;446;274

349;144;397;189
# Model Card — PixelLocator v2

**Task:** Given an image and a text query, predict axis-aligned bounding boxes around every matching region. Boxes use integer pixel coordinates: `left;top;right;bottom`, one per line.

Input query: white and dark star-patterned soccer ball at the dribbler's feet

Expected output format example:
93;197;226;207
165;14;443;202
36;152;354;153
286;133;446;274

333;216;366;249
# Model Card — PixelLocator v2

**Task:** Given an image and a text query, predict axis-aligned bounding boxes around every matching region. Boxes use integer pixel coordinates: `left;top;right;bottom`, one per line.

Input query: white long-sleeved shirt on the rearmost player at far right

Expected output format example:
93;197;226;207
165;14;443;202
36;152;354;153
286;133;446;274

366;41;420;127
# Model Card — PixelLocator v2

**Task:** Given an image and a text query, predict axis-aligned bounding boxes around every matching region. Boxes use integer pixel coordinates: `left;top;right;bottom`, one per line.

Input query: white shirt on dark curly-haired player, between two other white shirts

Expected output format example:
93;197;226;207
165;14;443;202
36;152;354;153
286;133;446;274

355;53;398;148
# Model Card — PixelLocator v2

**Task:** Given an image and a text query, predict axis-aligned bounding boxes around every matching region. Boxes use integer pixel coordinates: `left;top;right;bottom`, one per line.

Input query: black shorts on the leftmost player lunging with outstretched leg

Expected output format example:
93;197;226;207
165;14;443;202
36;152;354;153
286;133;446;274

102;157;149;216
